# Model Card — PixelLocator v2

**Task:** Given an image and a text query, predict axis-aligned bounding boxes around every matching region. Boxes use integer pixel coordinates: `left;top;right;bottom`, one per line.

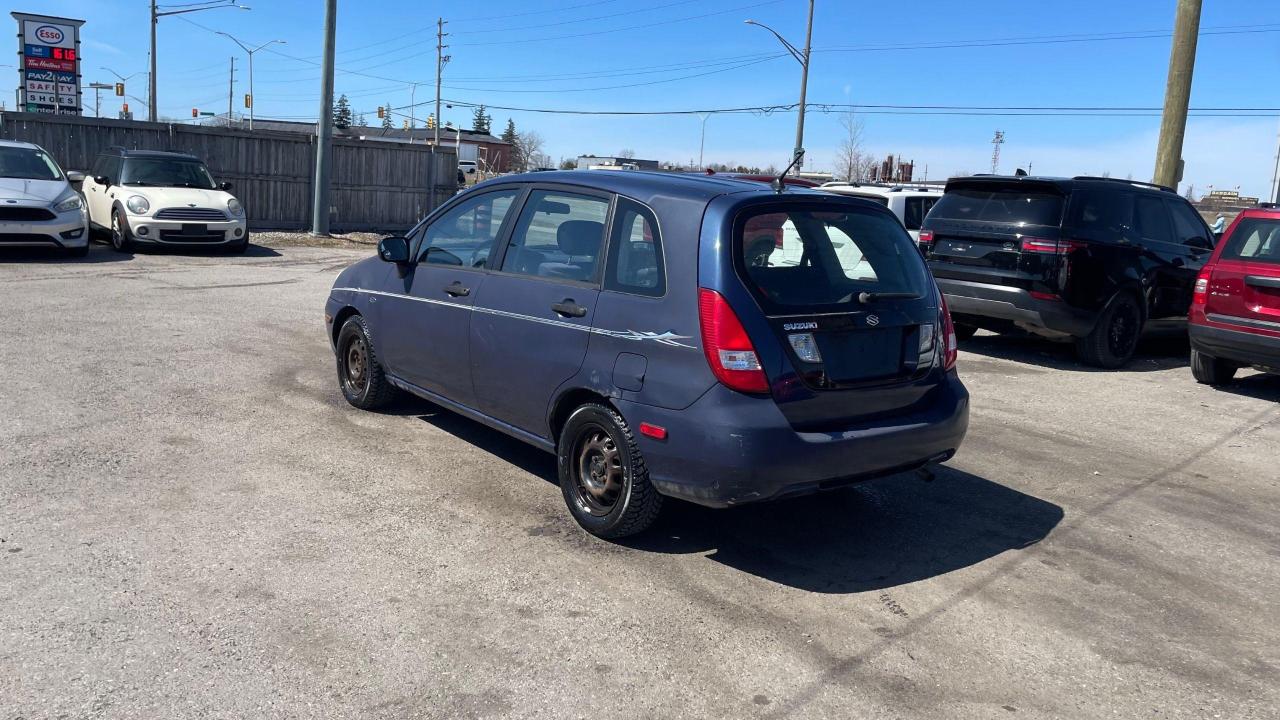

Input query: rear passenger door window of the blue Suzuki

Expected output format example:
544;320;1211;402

502;190;609;282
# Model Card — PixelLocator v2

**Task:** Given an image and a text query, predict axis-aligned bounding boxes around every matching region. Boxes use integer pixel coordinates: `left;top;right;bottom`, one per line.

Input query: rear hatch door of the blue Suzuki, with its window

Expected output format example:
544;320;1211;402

733;202;941;429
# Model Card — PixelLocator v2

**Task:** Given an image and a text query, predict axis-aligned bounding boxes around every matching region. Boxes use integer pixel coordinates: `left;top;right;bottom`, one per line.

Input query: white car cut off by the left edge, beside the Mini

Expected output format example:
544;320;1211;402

0;140;88;258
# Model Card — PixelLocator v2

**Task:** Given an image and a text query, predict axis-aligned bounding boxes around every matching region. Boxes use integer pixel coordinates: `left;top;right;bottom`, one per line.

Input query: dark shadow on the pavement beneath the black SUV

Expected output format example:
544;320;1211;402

960;329;1192;373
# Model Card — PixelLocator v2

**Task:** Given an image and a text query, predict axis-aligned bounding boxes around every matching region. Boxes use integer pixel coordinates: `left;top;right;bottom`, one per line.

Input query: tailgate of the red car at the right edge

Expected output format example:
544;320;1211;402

1204;214;1280;337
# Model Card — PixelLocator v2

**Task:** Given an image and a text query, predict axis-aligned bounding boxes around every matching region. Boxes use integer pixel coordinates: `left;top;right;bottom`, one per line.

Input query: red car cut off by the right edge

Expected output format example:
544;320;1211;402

1189;206;1280;384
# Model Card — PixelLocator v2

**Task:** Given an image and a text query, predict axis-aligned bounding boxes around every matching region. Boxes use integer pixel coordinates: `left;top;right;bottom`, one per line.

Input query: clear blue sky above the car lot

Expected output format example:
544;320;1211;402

22;0;1280;196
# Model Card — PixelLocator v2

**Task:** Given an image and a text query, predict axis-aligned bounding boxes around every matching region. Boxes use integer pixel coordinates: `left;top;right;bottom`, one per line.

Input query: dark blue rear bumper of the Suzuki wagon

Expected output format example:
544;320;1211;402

614;372;969;507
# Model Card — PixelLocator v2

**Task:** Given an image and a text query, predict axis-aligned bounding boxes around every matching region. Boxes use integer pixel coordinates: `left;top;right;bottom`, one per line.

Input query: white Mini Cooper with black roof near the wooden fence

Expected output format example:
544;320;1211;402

84;147;248;252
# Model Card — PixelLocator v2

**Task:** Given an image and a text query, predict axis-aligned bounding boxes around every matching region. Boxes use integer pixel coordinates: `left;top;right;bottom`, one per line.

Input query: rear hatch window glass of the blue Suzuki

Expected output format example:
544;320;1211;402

735;209;928;311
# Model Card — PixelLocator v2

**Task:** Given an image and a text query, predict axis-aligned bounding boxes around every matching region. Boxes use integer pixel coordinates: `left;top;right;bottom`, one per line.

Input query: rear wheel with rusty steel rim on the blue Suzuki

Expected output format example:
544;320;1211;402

556;404;662;538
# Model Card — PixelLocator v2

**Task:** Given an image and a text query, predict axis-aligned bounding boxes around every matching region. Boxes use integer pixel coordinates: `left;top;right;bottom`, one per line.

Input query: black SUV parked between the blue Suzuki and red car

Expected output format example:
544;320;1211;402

919;176;1213;368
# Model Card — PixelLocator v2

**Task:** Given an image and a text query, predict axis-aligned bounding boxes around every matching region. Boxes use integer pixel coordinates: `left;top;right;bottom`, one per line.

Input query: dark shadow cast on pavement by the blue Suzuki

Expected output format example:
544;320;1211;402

404;398;1062;593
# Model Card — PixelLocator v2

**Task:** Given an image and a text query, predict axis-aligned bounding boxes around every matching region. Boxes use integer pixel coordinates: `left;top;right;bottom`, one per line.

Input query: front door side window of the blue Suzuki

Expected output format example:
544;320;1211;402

417;190;520;268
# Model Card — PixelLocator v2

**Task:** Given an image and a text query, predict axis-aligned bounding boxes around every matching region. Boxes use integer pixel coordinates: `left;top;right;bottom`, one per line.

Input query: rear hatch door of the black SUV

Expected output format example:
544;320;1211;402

924;179;1066;290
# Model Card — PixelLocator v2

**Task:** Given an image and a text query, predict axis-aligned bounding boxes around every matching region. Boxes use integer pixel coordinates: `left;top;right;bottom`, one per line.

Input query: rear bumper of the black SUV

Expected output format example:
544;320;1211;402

936;278;1097;337
